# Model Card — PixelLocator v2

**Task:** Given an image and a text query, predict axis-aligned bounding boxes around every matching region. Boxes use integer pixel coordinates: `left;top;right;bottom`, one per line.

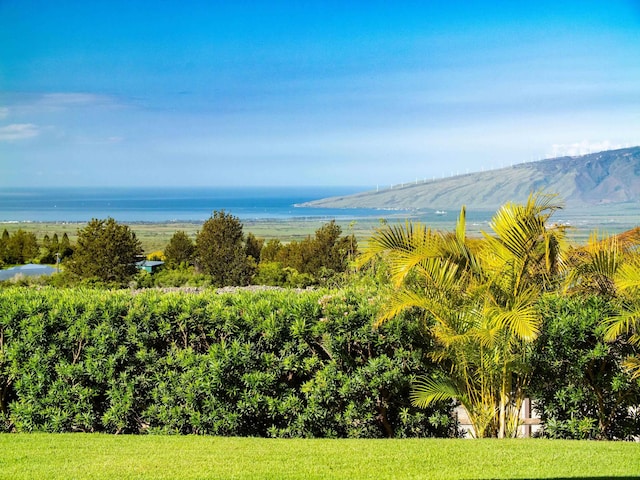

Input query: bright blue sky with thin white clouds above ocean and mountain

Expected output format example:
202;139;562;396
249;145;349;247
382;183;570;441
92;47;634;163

0;0;640;188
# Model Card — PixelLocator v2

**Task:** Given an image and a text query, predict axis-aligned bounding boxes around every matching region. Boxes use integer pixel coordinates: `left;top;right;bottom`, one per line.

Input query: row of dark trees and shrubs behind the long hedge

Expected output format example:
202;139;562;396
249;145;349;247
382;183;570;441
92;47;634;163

0;211;357;287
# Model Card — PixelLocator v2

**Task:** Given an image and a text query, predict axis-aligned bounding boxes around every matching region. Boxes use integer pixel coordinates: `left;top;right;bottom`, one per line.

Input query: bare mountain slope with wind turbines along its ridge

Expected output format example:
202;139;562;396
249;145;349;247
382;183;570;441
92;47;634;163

302;147;640;210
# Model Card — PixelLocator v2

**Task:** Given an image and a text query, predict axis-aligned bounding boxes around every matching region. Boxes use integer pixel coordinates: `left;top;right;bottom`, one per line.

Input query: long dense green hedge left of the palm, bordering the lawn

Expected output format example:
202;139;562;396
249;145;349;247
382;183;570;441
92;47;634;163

0;288;455;437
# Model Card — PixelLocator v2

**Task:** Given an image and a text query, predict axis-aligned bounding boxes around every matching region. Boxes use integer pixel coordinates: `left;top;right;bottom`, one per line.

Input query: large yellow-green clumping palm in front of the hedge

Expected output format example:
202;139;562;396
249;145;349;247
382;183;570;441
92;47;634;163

362;194;564;438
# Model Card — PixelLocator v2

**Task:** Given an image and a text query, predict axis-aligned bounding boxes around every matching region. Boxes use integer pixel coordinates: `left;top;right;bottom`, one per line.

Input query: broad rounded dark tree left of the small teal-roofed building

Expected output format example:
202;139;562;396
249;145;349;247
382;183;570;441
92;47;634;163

65;218;143;284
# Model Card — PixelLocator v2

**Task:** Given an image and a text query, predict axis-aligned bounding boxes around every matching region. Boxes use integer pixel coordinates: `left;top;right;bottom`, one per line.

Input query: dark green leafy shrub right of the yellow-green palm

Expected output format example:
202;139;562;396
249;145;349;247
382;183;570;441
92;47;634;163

530;296;640;439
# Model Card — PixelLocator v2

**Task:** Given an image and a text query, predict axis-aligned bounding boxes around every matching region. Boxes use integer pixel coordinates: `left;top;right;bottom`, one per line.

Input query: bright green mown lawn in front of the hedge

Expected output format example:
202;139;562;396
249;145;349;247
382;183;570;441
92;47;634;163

0;434;640;480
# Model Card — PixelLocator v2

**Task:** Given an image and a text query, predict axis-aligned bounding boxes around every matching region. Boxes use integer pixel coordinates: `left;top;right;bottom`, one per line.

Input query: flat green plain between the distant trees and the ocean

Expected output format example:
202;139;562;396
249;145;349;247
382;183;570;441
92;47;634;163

0;204;640;252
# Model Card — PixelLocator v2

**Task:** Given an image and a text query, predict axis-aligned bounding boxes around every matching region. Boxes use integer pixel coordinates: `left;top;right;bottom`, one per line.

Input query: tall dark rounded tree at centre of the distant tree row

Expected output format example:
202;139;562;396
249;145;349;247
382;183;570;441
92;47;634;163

196;210;255;286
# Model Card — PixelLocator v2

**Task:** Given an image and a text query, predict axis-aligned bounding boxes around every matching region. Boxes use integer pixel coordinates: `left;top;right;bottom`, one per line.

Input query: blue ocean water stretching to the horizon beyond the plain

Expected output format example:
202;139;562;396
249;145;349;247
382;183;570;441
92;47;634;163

0;187;399;222
